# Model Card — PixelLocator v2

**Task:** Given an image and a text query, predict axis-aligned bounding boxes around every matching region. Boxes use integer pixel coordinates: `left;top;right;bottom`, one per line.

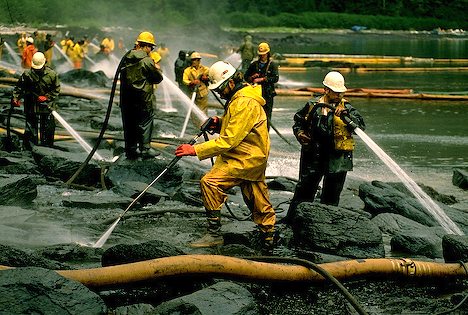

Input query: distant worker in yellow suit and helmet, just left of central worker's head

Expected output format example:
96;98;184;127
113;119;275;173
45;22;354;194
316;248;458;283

183;51;210;126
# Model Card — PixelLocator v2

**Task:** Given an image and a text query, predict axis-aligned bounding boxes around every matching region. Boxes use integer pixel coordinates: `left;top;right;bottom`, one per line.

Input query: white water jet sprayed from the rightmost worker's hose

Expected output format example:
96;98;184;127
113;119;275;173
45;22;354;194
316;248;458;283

354;128;464;235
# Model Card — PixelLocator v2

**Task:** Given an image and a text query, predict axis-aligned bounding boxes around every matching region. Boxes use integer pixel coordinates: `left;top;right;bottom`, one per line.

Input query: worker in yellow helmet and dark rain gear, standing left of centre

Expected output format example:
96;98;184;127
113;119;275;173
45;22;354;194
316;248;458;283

120;32;163;160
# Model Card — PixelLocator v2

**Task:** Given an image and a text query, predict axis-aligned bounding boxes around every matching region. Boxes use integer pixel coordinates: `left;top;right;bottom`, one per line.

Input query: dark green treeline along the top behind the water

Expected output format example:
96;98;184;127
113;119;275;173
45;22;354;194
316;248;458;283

0;0;468;30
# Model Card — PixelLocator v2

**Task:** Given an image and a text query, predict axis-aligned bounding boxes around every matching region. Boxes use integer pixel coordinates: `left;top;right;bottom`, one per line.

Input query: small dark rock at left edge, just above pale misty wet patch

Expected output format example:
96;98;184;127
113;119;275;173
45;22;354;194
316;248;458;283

0;174;37;205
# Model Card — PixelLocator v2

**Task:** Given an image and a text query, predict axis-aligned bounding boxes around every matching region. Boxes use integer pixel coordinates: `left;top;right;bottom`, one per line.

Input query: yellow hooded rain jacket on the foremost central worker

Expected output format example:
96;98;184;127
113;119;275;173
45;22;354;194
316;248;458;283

194;85;270;181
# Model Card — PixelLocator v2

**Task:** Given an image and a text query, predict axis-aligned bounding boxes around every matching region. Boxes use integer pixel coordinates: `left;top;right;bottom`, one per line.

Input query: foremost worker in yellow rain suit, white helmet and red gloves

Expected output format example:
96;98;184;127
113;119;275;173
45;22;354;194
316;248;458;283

175;61;276;249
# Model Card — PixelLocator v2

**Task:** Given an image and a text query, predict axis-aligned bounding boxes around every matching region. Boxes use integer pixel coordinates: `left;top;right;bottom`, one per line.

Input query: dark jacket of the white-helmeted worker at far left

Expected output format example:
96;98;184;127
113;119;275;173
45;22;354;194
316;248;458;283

13;67;60;109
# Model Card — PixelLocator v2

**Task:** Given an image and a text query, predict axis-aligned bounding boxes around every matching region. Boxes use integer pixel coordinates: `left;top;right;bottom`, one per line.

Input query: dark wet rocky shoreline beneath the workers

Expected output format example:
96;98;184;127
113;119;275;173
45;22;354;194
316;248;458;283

0;66;468;314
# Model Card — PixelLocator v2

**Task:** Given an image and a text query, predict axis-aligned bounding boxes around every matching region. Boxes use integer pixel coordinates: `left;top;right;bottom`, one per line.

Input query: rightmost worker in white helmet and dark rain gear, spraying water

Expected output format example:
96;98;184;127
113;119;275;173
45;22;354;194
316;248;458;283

285;71;365;221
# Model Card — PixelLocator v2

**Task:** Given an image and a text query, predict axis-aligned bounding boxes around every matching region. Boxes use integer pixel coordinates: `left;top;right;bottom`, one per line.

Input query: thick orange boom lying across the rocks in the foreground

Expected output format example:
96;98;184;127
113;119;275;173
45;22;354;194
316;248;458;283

0;255;468;287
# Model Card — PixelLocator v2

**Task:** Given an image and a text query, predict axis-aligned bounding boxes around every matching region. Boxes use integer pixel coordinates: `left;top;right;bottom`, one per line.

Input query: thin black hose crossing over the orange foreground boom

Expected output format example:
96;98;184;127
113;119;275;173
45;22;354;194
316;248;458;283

242;256;368;315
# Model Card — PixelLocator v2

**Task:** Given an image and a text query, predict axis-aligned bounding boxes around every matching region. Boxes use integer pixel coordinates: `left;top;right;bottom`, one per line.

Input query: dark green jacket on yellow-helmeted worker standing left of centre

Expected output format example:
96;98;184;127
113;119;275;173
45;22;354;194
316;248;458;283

120;50;163;109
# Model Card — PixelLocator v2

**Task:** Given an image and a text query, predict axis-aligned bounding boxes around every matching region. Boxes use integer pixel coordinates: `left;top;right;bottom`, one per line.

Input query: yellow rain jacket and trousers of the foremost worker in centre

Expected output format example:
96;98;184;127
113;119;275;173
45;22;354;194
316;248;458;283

194;85;276;232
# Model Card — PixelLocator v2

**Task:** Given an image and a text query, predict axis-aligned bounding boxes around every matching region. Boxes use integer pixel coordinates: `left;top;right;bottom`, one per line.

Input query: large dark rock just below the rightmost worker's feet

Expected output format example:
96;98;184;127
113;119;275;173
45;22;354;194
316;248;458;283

292;202;385;258
